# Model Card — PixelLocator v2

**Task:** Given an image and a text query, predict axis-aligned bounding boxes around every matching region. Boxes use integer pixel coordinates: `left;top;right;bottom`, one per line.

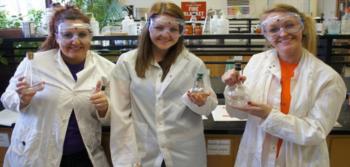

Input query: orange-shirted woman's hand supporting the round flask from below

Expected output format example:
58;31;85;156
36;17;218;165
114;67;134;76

230;101;272;119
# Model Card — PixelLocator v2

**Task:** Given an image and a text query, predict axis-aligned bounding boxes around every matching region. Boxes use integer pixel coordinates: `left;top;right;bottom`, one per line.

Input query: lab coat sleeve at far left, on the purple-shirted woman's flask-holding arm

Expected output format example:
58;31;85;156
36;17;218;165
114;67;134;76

1;58;30;112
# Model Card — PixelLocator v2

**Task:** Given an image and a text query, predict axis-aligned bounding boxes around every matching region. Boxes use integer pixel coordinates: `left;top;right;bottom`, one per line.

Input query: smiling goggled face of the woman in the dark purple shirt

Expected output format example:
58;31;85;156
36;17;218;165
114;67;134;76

56;20;92;64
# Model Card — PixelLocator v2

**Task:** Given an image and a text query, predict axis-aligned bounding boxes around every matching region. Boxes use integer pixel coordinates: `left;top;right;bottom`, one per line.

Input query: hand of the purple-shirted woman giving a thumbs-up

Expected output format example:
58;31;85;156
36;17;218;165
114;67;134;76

90;81;109;117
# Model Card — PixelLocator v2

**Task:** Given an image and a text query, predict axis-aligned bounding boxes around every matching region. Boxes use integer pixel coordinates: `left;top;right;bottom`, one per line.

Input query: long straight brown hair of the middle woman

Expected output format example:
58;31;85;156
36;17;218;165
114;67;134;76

135;2;185;80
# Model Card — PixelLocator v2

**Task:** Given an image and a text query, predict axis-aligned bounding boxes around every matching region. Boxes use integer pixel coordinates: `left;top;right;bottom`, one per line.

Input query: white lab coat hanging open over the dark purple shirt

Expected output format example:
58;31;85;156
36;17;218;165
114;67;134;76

1;49;114;167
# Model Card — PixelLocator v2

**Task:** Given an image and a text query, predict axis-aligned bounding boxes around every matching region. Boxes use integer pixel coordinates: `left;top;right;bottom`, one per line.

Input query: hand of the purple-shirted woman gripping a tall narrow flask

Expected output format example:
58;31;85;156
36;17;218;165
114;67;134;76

16;77;44;109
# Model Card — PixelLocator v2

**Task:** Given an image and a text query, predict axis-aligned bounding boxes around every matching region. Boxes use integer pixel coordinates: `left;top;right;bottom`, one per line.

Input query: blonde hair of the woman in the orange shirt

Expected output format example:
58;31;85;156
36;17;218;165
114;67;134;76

260;4;317;55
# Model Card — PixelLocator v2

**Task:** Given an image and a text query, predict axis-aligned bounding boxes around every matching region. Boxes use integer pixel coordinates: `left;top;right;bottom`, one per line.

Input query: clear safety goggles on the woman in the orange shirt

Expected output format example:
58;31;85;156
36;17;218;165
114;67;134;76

260;13;304;39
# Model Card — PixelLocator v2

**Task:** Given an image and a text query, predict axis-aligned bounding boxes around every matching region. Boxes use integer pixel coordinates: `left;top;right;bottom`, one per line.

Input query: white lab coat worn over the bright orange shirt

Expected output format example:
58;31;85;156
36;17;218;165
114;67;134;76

227;49;346;167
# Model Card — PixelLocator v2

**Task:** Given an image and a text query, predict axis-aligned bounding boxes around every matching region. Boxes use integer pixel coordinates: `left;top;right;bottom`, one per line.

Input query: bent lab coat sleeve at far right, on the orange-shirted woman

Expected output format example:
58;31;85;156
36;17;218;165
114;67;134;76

260;76;346;145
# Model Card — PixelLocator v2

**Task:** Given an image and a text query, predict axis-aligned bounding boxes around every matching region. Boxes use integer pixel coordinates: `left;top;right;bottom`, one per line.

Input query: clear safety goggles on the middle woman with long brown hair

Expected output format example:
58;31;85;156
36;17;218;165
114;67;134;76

149;16;184;37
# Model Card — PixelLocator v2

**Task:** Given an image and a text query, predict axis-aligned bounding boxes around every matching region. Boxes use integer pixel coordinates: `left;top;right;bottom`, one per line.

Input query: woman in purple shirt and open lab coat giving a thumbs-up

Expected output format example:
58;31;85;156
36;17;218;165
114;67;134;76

1;6;114;167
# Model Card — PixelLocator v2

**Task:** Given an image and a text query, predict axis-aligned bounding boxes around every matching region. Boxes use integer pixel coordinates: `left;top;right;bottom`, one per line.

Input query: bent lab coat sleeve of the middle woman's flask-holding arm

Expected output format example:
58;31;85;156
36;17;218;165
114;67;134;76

182;63;218;116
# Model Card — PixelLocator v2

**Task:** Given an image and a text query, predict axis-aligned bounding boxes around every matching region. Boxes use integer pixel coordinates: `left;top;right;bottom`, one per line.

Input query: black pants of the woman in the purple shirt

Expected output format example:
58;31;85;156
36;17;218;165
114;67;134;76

60;149;93;167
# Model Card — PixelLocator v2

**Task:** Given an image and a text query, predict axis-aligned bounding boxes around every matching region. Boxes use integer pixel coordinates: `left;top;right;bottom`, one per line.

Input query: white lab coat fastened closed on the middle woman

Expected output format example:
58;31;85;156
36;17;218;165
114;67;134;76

111;49;217;167
